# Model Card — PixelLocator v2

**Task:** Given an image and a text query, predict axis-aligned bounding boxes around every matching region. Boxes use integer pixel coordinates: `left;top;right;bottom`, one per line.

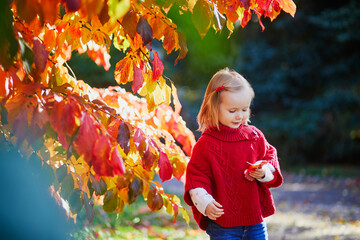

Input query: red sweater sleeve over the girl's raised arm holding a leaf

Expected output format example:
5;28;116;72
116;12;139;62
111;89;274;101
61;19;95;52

256;129;283;188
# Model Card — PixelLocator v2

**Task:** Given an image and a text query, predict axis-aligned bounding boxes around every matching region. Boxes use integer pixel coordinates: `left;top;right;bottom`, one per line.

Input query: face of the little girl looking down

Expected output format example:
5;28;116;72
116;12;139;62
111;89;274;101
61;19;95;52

219;88;252;128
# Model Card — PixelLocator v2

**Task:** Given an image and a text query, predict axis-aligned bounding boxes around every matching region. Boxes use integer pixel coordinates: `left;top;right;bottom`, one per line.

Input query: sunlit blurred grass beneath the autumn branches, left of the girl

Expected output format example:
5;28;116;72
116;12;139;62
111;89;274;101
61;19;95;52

70;198;207;240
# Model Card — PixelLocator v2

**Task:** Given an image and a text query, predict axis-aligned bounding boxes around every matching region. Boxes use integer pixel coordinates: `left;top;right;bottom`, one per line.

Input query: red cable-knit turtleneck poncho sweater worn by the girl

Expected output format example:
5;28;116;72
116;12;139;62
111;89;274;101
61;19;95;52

184;125;283;230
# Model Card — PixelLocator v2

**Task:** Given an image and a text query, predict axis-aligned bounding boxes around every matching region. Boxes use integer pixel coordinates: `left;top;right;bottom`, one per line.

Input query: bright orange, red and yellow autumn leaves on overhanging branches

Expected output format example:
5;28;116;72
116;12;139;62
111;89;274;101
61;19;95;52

0;0;296;221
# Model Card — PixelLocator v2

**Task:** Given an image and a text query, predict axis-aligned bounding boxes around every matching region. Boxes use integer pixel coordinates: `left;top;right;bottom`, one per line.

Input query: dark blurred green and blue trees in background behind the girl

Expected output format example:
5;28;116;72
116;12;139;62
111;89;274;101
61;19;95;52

70;0;360;168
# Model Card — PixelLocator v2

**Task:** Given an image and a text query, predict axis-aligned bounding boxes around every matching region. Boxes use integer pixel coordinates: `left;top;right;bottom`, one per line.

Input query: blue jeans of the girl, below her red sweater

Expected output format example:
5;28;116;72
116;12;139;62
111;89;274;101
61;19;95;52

206;220;268;240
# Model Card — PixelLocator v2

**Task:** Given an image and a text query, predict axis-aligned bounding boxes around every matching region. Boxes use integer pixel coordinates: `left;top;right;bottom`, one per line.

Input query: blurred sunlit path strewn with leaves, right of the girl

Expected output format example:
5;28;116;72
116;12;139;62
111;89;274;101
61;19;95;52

163;173;360;240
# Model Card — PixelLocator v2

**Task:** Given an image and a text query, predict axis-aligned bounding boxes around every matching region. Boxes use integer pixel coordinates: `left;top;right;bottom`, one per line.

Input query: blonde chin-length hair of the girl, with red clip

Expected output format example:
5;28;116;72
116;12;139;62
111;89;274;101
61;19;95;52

197;68;255;132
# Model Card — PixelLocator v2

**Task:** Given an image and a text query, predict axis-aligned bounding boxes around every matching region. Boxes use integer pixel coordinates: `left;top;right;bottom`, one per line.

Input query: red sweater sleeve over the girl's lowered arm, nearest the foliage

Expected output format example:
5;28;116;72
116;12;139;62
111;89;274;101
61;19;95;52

184;139;212;206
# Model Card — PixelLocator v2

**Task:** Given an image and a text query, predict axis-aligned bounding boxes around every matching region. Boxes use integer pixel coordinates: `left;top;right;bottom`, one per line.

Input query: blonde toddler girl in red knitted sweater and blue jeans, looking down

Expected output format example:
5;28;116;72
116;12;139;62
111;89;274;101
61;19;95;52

184;68;283;240
